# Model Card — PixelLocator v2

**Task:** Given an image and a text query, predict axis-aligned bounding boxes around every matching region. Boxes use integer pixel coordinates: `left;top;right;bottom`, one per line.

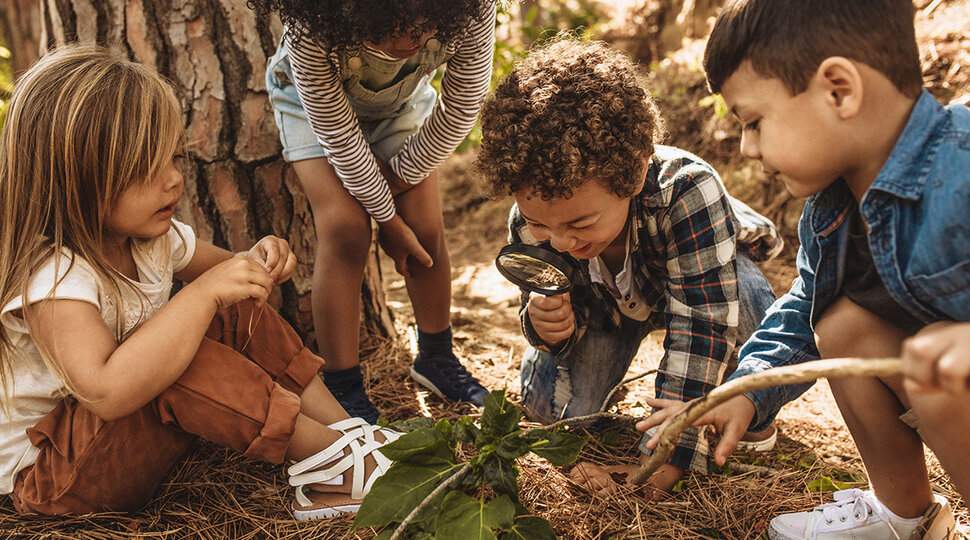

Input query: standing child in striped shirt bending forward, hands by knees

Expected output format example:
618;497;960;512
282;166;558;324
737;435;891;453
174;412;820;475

248;0;495;428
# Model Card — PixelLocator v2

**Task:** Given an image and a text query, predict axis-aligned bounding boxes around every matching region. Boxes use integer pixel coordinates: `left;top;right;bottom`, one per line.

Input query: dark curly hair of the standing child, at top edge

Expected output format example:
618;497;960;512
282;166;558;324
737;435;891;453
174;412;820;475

246;0;492;51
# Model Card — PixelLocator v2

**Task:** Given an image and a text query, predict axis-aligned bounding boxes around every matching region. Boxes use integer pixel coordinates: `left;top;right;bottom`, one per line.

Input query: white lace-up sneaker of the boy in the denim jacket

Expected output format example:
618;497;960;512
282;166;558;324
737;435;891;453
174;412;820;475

768;489;956;540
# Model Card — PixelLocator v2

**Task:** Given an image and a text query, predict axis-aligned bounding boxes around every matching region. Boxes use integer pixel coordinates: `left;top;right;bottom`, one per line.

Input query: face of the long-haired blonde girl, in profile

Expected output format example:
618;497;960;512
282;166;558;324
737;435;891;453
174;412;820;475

106;156;183;238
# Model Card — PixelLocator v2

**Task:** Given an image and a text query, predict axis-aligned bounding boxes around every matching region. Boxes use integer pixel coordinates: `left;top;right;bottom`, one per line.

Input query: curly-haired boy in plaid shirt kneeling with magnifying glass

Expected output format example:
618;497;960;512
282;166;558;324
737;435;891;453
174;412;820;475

477;39;781;491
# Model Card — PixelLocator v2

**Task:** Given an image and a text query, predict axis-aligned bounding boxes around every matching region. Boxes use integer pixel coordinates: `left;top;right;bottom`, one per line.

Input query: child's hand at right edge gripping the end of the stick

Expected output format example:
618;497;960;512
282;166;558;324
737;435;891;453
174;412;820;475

902;321;970;394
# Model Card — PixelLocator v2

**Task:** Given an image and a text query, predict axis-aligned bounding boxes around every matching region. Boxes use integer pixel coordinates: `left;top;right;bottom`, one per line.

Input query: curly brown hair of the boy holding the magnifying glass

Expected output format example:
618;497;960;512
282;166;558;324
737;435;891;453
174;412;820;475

475;36;663;201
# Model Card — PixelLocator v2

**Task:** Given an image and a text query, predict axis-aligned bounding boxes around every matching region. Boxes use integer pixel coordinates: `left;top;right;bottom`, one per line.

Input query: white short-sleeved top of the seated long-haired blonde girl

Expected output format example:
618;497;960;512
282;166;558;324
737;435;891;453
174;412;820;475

0;220;195;495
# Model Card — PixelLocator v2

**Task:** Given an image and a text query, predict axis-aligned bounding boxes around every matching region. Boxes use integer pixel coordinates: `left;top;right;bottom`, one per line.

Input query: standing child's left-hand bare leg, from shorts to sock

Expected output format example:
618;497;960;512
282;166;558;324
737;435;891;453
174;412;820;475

293;158;371;371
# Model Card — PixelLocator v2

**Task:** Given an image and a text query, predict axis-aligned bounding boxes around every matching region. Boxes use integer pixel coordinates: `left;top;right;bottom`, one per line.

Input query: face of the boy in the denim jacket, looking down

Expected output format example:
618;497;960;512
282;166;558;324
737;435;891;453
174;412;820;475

721;62;846;197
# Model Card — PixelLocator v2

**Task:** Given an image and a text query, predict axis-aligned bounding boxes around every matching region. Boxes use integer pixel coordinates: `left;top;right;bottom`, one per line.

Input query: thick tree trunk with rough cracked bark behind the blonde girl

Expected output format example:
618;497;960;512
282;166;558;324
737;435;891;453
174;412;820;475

0;0;394;340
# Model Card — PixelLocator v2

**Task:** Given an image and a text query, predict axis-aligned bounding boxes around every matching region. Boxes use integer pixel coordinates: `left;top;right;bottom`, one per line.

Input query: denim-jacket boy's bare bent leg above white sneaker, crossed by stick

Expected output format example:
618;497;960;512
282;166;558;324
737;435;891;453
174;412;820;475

815;297;932;518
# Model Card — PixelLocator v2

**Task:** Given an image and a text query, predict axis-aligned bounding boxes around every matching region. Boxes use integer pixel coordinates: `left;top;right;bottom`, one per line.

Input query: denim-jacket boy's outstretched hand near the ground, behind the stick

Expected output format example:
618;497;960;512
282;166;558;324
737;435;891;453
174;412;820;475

637;396;755;465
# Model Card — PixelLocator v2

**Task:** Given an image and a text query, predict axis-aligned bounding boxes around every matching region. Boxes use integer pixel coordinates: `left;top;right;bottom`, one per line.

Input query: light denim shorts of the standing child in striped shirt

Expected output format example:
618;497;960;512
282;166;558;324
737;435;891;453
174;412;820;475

266;45;438;162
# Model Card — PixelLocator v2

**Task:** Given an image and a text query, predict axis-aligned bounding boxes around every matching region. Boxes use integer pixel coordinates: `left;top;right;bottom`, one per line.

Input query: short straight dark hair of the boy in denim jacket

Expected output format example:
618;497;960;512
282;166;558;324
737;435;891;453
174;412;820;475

704;0;923;97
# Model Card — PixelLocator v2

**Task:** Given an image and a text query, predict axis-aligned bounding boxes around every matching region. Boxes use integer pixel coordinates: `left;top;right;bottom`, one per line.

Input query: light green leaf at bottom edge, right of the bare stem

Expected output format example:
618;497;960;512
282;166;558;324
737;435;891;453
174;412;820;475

435;491;515;540
